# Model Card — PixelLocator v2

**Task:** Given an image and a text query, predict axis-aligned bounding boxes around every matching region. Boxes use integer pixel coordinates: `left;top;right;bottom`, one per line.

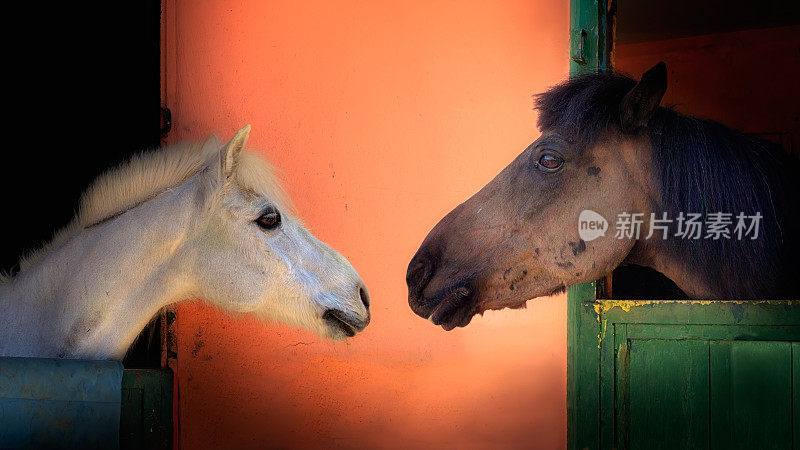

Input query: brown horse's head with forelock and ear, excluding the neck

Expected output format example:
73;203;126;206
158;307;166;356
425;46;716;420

406;63;667;330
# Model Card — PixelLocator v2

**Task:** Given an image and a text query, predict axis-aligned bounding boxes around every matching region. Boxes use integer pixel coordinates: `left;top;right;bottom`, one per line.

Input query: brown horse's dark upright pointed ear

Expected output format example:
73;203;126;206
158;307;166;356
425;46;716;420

620;61;667;134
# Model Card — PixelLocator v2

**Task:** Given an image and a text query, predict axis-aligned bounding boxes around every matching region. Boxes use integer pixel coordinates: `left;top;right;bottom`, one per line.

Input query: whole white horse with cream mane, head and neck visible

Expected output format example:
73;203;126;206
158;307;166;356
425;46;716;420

0;125;370;360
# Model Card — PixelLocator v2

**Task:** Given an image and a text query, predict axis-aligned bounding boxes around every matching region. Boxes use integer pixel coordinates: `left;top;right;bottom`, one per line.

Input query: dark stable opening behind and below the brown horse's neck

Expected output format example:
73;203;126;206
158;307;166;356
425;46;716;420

611;0;800;299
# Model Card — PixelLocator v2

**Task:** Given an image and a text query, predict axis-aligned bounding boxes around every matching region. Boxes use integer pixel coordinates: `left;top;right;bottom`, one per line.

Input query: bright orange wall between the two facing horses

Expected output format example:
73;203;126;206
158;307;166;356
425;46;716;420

164;0;569;449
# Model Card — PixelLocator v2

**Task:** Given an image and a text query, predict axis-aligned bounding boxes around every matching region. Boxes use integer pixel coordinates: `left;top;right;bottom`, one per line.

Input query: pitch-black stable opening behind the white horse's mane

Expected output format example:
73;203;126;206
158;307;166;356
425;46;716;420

0;0;161;365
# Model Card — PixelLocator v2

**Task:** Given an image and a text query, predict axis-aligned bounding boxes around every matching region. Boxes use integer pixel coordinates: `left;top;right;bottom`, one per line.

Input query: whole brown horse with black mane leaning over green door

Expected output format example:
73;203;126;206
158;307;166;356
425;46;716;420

406;63;800;330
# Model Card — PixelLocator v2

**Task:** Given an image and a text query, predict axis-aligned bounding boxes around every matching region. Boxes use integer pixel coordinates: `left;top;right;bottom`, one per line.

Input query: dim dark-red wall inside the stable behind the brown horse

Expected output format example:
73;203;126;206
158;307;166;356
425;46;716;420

614;26;800;156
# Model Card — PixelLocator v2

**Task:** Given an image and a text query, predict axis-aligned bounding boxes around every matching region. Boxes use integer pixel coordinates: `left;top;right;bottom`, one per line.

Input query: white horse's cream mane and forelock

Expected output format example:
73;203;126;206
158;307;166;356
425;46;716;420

0;135;292;285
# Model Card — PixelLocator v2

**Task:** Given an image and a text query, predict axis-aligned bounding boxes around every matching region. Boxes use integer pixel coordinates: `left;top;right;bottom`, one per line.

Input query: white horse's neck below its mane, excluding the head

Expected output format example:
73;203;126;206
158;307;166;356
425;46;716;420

0;178;198;359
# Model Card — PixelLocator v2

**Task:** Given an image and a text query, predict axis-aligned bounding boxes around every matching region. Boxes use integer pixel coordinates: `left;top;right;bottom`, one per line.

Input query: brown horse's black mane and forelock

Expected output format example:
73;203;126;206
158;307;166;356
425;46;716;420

536;74;800;298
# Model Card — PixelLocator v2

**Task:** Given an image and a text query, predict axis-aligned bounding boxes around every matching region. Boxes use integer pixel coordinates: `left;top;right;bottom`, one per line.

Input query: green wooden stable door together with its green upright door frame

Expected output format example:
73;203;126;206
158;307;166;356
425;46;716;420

567;0;800;450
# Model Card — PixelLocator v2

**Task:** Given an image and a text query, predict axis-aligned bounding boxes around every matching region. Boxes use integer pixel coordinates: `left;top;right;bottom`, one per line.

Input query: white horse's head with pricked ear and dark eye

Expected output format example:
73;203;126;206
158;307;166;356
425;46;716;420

185;126;370;340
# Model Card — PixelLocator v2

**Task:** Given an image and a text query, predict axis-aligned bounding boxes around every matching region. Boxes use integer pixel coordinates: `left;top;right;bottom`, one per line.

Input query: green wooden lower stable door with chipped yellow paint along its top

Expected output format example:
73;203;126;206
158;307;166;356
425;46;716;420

600;300;800;449
